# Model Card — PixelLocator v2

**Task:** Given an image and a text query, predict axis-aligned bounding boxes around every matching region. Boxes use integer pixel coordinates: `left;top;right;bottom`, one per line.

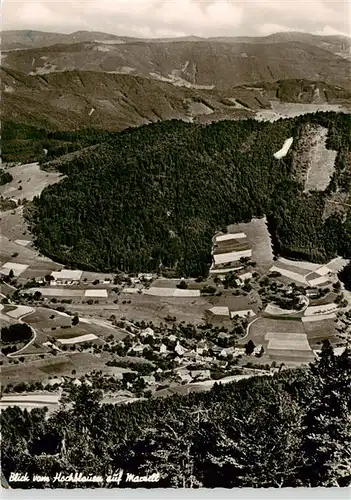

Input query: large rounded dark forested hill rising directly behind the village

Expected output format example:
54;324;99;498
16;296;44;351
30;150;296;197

30;113;351;276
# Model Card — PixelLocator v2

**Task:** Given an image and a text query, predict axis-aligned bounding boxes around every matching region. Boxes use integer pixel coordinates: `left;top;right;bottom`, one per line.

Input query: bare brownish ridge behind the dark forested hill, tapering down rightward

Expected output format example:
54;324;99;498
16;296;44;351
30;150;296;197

1;69;253;130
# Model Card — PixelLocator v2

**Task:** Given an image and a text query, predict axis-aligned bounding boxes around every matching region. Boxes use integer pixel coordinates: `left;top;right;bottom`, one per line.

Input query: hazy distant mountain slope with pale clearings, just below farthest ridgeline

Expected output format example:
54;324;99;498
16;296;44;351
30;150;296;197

2;41;350;89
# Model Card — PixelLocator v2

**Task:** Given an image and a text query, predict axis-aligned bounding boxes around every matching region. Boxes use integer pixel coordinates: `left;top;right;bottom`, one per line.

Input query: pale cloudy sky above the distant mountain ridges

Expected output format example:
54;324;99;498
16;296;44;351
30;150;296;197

2;0;351;37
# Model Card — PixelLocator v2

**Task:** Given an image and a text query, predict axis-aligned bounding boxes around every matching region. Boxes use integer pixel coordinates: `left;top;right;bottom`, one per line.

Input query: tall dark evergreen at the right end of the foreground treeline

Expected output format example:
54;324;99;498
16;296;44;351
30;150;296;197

300;341;351;487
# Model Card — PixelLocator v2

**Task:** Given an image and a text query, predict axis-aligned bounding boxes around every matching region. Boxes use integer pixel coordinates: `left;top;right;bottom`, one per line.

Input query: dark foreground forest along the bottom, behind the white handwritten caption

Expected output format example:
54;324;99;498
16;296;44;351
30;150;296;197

1;342;351;488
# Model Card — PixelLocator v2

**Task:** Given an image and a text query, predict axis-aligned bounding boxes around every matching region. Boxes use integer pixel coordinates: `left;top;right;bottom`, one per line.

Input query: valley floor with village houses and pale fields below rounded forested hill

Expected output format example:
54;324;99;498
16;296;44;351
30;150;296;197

0;164;351;411
